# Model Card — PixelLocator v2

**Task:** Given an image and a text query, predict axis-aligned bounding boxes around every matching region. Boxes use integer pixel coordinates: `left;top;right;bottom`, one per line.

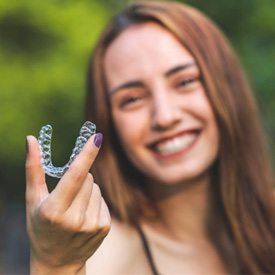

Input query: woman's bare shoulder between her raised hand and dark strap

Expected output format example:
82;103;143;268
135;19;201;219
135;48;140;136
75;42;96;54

86;219;150;275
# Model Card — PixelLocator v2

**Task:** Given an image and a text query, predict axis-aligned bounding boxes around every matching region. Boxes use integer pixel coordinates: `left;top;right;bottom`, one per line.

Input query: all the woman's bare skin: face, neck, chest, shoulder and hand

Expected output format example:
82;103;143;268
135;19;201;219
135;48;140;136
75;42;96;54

26;24;225;275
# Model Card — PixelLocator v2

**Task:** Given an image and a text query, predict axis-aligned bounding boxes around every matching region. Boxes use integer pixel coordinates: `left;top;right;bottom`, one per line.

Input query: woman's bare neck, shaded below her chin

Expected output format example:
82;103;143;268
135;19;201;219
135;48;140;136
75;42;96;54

146;175;213;241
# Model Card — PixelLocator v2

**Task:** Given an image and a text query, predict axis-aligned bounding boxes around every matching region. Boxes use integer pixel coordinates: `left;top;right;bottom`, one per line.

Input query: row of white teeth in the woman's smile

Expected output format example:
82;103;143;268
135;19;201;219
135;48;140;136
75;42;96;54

156;134;197;154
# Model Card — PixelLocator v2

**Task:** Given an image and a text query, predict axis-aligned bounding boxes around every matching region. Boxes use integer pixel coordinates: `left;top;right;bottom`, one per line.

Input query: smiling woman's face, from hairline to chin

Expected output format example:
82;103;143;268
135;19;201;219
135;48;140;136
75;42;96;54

104;23;219;184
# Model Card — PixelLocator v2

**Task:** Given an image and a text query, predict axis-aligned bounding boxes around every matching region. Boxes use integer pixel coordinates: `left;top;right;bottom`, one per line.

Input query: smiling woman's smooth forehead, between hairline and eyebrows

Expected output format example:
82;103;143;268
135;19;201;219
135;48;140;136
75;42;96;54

104;23;195;83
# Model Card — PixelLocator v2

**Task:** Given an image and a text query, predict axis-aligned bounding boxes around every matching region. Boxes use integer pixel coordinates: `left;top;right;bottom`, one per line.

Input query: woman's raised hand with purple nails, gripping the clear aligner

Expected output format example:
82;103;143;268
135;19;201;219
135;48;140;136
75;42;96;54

26;134;110;275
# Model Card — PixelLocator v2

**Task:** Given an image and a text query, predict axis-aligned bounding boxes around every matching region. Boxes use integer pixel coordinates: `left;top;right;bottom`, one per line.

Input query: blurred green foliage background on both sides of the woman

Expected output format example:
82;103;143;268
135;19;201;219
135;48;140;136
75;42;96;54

0;0;275;274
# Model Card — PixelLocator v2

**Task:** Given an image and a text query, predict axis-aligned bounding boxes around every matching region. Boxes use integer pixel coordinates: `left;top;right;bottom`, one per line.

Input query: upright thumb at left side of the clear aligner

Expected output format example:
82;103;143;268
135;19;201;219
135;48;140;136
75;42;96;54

25;136;49;207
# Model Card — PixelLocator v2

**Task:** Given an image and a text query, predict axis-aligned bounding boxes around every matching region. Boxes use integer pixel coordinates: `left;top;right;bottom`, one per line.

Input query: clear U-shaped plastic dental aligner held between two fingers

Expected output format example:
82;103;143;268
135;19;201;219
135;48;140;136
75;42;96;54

38;121;96;178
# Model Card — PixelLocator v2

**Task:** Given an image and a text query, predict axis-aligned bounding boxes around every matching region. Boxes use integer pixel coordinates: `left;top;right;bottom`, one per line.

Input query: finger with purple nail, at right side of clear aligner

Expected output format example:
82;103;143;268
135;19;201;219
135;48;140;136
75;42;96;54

49;133;103;208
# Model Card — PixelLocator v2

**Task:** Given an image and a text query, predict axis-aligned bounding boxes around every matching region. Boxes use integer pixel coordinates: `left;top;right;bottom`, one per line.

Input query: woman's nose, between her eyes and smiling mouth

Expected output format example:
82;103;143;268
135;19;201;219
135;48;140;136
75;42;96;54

151;95;181;130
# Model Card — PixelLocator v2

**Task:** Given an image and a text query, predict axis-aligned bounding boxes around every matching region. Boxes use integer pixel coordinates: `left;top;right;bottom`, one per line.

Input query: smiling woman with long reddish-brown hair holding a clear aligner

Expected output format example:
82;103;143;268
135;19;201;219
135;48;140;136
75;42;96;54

24;2;275;274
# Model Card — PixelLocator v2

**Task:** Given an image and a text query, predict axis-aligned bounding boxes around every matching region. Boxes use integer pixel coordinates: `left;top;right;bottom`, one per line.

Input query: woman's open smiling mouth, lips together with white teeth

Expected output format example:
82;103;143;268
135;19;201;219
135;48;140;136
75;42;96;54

150;130;200;157
